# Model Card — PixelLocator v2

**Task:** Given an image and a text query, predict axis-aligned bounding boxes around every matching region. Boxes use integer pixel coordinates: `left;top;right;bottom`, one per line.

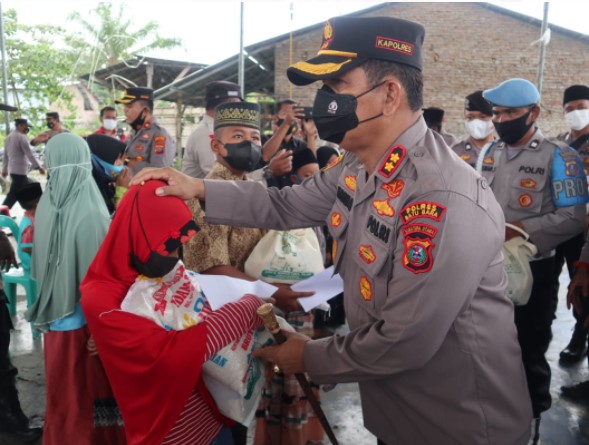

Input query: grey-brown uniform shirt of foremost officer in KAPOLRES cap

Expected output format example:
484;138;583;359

205;118;532;445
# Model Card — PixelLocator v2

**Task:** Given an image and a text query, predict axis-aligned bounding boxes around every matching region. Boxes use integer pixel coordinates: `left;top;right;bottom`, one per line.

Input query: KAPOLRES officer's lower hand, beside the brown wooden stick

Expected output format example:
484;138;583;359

253;331;311;374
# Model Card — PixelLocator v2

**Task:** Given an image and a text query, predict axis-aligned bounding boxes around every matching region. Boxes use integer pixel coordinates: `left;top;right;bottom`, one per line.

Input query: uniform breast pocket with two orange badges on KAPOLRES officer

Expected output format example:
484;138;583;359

348;234;392;313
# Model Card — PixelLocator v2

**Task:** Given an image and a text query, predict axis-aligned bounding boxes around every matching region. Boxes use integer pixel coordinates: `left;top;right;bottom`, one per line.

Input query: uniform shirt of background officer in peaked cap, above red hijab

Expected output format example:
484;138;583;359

125;117;176;175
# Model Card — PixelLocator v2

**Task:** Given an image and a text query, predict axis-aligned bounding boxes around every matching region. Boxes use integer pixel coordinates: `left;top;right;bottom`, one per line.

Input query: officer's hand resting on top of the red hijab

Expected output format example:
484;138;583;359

129;167;205;200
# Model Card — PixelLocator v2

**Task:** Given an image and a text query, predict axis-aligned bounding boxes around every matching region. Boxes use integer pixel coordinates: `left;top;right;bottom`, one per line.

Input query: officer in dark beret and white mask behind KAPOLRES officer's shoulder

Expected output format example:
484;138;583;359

452;90;495;168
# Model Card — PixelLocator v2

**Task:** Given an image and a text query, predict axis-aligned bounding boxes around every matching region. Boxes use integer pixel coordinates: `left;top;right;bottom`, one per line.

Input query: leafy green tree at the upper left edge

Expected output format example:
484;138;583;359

4;9;76;125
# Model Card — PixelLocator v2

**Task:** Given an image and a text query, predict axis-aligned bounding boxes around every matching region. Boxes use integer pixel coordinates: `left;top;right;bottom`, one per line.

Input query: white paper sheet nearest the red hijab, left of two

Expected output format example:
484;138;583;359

196;274;278;311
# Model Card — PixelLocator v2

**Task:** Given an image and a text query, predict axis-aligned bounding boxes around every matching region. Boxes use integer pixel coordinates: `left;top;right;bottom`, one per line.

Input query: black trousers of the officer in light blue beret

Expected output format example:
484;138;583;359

515;257;556;417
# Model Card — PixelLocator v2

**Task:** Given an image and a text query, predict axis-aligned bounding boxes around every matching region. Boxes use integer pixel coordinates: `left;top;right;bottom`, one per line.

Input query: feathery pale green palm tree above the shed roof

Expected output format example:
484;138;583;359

66;2;181;74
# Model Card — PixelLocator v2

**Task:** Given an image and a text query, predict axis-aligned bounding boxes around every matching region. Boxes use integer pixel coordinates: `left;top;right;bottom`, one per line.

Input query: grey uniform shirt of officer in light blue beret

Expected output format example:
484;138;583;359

482;130;585;255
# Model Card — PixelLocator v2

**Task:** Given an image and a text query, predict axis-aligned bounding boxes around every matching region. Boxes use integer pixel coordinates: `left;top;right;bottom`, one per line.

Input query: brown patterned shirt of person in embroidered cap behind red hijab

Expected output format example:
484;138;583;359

184;162;264;272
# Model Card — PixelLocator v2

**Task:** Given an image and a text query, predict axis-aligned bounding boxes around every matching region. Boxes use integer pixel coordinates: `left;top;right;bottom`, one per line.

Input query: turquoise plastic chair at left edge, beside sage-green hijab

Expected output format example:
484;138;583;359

0;215;39;338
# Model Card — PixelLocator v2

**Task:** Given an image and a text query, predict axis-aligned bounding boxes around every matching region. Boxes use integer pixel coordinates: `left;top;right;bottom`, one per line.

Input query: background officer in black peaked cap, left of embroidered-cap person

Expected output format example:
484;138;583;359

115;88;176;174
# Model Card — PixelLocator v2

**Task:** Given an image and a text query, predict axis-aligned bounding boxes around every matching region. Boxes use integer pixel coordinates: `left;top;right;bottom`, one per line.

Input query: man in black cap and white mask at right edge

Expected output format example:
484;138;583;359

554;85;589;362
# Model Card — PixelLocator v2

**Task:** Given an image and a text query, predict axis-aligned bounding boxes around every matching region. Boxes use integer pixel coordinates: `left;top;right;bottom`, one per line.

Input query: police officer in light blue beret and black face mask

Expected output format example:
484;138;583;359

482;78;588;443
